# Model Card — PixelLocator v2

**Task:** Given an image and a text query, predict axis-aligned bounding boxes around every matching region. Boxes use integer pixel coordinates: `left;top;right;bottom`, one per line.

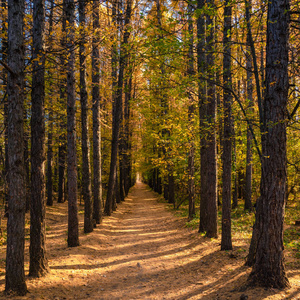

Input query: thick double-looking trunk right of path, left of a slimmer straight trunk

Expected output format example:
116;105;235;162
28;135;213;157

198;0;218;238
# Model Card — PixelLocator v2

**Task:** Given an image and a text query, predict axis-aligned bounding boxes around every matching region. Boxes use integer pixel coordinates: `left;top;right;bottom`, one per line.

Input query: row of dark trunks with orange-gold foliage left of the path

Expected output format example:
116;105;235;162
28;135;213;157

1;0;134;295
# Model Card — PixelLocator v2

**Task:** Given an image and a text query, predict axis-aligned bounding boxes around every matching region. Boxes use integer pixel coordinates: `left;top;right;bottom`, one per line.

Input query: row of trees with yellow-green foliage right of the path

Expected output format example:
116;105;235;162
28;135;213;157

141;0;299;288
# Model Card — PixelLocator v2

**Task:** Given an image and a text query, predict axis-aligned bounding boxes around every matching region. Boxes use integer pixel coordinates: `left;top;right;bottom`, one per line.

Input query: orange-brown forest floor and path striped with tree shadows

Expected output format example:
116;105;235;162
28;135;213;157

0;183;300;300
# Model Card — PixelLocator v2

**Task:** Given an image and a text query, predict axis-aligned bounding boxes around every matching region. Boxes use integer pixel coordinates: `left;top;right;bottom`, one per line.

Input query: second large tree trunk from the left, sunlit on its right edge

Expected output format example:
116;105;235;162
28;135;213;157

29;0;48;277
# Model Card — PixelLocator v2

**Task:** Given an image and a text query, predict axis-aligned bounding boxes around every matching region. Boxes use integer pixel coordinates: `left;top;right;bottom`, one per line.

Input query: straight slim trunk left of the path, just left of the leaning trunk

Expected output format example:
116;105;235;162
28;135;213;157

92;0;102;224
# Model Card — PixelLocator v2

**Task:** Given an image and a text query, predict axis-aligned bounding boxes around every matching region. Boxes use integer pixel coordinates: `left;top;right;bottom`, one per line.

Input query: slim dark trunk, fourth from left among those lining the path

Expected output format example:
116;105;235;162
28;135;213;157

78;1;93;233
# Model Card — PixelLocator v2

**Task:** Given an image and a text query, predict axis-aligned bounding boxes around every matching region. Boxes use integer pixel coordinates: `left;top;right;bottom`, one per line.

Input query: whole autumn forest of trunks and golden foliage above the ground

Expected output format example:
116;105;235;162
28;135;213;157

0;0;300;295
